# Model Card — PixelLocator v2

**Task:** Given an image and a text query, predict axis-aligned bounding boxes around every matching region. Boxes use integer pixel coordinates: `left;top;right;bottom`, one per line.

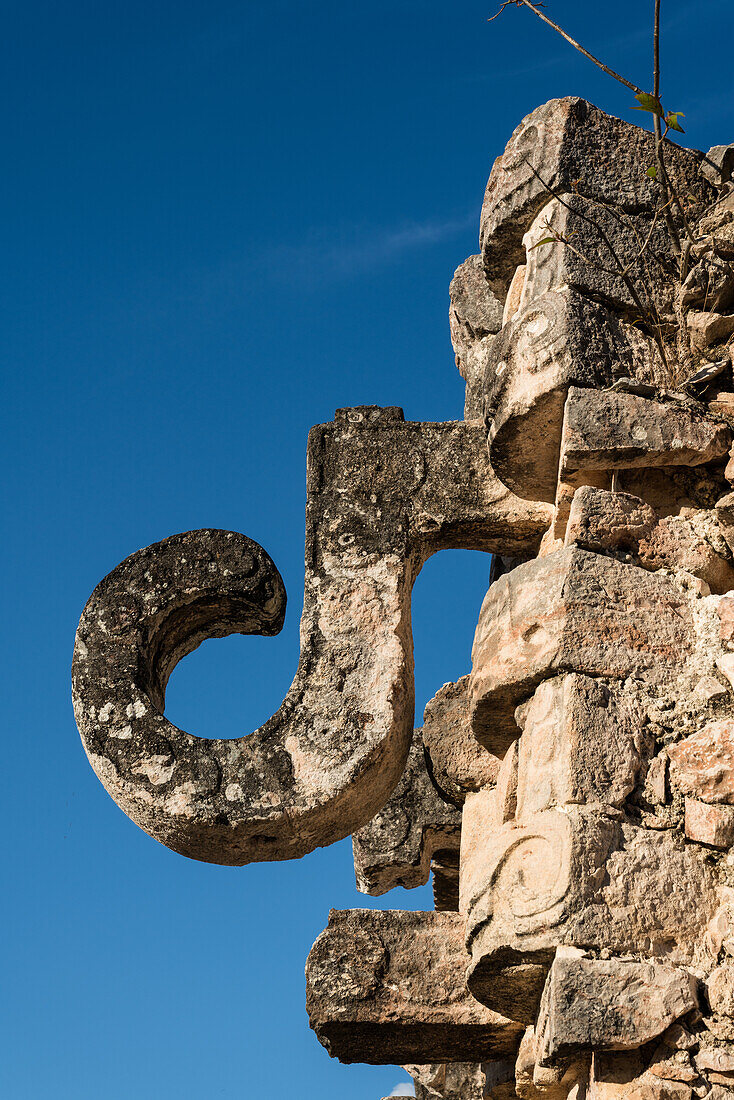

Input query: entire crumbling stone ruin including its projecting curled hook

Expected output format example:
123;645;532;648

74;99;734;1100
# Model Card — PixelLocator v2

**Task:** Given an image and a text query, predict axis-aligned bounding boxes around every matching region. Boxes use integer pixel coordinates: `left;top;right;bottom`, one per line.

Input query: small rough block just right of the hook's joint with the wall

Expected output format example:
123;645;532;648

565;485;657;553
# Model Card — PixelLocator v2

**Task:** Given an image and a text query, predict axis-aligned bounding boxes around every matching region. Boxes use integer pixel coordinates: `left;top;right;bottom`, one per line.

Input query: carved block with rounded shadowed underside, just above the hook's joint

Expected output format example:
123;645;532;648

484;287;659;502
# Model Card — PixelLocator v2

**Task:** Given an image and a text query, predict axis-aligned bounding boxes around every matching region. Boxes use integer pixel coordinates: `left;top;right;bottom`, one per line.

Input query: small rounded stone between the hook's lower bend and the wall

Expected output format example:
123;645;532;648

423;677;500;805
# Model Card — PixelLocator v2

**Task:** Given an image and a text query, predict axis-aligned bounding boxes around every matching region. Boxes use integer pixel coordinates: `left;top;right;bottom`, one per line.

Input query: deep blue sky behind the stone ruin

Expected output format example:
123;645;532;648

5;0;734;1100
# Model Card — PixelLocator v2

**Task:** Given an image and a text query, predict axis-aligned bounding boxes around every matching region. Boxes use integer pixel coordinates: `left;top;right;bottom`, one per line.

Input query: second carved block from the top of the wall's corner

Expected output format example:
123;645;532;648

521;194;677;319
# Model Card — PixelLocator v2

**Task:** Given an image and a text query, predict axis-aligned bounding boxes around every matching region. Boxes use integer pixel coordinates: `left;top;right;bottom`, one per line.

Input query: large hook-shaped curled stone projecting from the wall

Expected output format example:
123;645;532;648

73;407;548;864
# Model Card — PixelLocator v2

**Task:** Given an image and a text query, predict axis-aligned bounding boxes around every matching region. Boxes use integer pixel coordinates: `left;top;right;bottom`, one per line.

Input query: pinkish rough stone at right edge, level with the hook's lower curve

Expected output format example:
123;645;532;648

668;718;734;805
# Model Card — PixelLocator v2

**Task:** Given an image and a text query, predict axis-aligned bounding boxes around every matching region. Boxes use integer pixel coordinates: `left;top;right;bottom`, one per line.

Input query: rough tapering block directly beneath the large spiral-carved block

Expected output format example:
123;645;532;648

536;948;699;1066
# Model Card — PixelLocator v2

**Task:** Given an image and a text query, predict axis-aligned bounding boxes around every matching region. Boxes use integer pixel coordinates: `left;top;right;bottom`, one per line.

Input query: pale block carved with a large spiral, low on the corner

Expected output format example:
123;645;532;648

462;818;717;1023
